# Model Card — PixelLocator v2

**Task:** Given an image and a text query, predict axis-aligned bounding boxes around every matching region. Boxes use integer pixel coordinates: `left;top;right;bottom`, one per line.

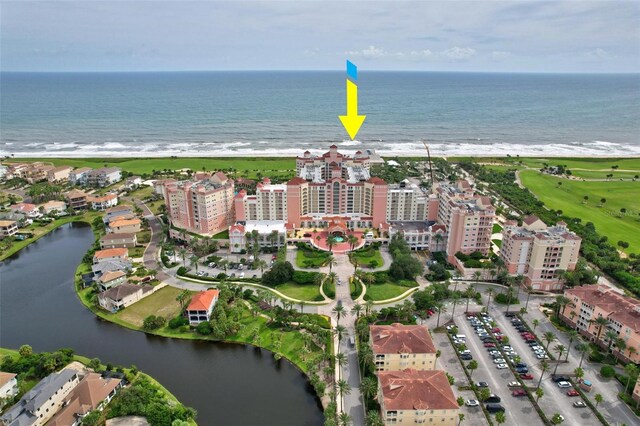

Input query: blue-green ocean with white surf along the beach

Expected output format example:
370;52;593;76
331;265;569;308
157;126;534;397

0;69;640;157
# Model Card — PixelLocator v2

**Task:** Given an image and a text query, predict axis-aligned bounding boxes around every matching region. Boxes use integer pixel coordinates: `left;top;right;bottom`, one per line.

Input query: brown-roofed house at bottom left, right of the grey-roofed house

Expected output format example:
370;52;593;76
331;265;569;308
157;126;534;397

47;373;124;426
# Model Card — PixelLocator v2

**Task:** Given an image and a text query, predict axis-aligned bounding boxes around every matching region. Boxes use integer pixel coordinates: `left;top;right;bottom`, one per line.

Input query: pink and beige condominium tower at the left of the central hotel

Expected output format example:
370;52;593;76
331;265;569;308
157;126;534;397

163;172;234;235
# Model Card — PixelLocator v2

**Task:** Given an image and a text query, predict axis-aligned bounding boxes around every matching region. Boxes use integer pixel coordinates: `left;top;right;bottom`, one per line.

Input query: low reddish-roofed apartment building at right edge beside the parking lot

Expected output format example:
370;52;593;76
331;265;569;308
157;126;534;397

560;284;640;363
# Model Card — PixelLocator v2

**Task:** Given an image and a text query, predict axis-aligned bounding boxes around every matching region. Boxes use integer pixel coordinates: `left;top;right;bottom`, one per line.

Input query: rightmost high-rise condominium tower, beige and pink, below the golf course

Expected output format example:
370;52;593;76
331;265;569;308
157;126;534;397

500;216;582;291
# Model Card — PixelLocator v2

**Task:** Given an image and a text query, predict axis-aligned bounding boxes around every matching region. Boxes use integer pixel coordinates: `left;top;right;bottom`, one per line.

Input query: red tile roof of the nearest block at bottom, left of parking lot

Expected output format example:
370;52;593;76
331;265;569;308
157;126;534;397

377;369;459;411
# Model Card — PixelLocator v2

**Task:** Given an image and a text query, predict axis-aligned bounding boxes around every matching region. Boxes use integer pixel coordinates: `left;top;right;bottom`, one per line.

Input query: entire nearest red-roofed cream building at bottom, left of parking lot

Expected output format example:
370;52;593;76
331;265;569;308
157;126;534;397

377;369;460;426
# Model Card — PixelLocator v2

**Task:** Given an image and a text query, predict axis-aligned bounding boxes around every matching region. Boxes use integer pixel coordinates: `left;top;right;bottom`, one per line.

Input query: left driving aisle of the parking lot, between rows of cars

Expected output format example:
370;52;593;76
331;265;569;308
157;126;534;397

456;313;543;425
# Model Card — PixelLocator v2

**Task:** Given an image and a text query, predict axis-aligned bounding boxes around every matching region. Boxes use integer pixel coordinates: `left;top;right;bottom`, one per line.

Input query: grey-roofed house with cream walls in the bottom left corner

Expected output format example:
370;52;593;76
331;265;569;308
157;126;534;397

0;368;80;426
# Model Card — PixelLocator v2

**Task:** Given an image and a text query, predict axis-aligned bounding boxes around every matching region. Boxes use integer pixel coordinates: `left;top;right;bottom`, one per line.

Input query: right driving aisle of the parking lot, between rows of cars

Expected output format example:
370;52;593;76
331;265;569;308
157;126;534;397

490;308;601;426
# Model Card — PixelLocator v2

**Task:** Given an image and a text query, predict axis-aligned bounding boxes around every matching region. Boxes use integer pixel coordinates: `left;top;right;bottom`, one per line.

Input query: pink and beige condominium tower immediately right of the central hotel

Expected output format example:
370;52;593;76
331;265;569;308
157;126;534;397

436;180;496;263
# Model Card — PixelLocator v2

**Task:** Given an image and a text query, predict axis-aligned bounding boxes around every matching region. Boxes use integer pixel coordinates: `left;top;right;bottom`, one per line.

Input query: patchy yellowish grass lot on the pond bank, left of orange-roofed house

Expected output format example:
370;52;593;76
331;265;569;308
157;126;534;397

114;286;186;327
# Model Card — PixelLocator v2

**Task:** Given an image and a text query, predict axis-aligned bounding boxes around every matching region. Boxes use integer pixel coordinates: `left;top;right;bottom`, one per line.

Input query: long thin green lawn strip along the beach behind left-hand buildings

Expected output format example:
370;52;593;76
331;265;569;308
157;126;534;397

10;157;295;178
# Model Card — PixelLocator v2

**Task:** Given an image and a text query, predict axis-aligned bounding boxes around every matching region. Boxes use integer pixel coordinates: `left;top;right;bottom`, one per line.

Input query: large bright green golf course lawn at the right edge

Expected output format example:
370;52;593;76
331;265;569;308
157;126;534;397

521;171;640;252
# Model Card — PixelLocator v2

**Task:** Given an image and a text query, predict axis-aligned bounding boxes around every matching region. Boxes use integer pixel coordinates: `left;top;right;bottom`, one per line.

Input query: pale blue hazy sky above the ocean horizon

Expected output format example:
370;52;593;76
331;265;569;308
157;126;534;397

0;0;640;72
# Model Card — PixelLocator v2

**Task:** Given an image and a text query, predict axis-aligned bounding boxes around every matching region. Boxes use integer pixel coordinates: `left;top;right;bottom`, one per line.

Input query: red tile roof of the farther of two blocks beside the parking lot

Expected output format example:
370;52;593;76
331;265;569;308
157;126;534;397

369;323;436;354
